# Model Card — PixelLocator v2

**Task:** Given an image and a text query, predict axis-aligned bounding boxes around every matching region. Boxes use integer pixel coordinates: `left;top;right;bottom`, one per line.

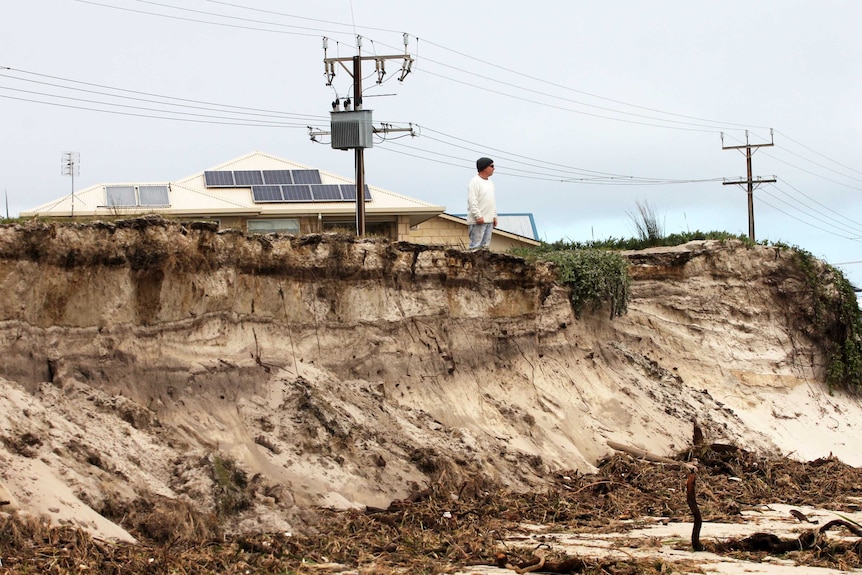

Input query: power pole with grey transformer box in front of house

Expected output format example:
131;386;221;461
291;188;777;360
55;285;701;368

320;33;413;236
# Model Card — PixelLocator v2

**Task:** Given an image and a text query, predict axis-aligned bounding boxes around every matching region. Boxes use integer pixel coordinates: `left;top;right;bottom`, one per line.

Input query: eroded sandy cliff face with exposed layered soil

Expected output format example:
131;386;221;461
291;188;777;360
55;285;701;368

0;218;860;536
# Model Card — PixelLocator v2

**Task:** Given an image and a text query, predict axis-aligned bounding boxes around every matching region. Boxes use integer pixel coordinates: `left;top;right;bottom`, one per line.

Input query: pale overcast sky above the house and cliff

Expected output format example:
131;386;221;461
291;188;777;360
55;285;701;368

0;0;862;285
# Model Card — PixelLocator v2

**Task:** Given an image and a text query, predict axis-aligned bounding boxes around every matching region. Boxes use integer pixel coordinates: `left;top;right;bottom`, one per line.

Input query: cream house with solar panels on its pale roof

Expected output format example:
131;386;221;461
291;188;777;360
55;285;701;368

21;152;540;251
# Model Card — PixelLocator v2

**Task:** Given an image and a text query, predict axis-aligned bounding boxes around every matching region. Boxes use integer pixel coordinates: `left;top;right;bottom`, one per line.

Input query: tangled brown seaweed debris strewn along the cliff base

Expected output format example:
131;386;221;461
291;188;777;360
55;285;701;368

0;446;862;575
